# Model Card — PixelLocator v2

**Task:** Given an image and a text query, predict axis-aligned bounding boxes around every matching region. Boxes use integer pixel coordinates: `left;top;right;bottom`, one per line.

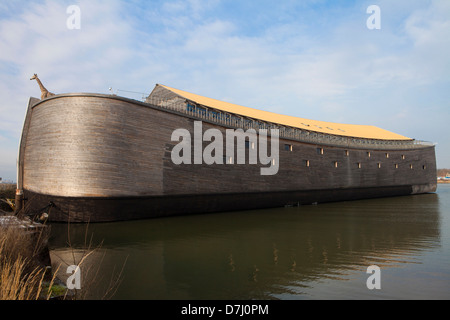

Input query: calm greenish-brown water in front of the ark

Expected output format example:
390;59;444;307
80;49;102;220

46;185;450;300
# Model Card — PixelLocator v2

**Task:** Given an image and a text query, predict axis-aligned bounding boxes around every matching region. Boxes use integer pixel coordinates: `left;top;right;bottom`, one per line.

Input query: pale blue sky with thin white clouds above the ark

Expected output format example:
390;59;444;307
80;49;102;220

0;0;450;180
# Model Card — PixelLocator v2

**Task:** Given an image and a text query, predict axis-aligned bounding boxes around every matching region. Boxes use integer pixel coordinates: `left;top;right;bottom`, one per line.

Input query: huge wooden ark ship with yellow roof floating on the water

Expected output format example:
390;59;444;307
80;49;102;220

16;85;436;222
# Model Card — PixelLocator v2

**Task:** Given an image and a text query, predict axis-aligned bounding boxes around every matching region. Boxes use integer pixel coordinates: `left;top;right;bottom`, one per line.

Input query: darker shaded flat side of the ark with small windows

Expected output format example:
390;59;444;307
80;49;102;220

163;120;436;194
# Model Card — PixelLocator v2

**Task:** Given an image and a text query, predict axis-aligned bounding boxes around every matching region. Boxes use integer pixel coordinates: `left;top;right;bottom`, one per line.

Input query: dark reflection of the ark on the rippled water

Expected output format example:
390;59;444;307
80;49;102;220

51;194;440;299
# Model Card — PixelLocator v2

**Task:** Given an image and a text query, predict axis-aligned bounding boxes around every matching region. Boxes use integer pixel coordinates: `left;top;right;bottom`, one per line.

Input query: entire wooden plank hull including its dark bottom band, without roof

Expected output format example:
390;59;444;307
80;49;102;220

22;94;436;222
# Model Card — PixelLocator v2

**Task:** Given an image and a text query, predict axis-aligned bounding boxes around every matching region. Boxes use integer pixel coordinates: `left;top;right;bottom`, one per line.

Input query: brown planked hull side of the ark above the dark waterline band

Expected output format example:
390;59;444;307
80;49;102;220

24;96;436;197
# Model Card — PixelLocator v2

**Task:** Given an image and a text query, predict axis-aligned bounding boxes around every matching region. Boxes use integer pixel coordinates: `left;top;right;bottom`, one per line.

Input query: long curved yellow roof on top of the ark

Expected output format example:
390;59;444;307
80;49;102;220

160;85;412;140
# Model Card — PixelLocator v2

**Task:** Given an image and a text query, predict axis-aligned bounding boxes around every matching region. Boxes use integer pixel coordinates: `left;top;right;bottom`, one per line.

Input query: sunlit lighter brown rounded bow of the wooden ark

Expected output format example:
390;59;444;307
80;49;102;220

24;96;187;197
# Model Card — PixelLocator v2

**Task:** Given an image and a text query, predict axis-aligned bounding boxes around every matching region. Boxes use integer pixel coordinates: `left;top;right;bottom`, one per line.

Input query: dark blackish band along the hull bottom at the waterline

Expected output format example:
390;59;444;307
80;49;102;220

25;186;413;223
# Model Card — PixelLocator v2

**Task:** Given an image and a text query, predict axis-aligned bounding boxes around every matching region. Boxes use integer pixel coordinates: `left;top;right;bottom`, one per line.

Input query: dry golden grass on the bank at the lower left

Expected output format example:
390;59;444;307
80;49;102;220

0;218;123;300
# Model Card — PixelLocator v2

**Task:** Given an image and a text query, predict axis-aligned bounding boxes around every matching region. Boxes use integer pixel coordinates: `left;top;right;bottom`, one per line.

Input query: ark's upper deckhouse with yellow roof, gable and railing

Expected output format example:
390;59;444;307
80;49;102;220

146;84;434;149
